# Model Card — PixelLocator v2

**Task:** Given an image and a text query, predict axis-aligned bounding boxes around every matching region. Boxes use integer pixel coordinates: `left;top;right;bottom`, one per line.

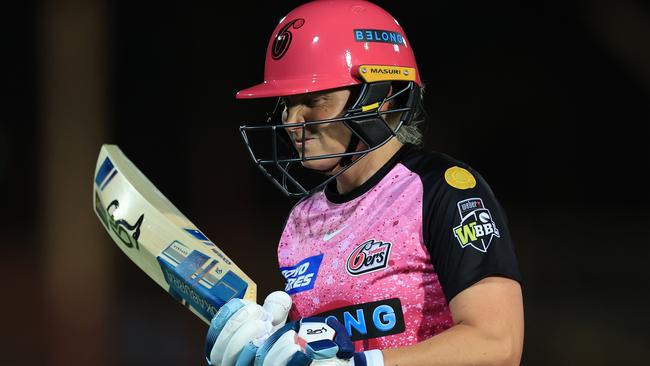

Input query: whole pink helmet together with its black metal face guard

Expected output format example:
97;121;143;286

237;0;422;196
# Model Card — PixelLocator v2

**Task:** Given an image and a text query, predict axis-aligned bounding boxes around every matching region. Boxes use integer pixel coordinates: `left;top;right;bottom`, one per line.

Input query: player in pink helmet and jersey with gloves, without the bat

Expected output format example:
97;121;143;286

206;0;524;366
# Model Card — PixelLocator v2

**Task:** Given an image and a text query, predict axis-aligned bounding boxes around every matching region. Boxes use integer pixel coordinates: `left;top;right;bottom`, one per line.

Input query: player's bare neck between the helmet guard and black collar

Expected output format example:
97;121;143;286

336;137;402;194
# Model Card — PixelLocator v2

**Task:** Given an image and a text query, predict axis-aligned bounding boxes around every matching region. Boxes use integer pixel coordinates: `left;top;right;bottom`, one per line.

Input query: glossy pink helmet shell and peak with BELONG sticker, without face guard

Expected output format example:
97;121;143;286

237;0;422;99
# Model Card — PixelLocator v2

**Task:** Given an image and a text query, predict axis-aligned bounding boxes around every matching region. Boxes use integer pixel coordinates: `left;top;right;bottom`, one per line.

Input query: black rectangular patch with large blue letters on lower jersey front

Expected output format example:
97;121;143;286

316;298;405;341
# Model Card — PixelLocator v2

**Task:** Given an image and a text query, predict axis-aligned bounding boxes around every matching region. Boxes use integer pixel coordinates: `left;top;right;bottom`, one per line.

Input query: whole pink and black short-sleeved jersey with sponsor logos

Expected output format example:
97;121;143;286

278;145;520;350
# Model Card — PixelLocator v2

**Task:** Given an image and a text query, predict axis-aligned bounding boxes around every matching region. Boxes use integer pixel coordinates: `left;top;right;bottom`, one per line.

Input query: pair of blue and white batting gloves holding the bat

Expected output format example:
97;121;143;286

205;291;384;366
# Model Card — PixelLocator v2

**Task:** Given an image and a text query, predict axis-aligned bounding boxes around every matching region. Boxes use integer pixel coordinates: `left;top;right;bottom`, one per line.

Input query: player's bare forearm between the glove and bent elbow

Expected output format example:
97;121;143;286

383;324;522;366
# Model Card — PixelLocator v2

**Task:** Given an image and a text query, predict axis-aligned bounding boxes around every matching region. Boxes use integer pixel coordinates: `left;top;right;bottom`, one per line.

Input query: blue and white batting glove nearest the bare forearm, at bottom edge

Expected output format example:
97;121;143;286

249;316;384;366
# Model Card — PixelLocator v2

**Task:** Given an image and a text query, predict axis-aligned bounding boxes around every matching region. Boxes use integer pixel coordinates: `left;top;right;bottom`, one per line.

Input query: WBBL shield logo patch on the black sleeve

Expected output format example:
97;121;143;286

453;198;500;253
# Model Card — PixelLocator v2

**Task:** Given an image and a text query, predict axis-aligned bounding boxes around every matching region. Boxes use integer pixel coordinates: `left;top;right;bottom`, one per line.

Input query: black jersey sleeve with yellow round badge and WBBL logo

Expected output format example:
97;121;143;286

423;165;521;301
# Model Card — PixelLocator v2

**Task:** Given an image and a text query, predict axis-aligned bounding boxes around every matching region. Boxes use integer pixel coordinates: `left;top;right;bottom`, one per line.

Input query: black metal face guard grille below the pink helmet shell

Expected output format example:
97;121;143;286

239;82;420;197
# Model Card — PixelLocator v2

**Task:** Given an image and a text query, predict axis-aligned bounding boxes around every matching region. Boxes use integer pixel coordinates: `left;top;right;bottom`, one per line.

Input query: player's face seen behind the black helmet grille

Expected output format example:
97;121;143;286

282;89;352;171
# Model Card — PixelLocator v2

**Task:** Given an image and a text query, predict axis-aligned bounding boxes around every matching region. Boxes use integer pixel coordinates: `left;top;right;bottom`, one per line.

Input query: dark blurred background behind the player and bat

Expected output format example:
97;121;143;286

0;0;650;365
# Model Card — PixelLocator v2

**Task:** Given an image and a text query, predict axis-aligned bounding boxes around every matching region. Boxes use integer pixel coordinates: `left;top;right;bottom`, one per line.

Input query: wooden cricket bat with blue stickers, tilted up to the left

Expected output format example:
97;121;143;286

93;145;257;323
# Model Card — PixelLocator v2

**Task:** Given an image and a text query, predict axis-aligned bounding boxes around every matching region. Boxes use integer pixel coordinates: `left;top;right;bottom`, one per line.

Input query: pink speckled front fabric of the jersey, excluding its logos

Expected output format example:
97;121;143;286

278;164;453;351
